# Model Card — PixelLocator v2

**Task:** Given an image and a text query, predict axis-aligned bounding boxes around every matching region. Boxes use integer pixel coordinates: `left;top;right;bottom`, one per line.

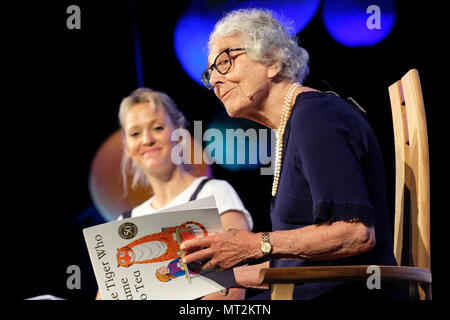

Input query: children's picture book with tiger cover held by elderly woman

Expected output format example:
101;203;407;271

83;196;235;300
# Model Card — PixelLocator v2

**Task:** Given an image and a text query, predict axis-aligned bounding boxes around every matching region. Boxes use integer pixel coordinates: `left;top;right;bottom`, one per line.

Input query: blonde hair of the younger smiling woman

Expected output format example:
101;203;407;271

119;88;188;195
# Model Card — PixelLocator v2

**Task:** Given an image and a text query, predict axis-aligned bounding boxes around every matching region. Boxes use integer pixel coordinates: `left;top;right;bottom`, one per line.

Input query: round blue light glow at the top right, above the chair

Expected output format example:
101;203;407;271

322;0;396;47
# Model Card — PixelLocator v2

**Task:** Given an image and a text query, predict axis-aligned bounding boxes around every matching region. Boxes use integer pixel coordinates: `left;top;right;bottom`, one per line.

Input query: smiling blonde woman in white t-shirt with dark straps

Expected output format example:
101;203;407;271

97;88;253;300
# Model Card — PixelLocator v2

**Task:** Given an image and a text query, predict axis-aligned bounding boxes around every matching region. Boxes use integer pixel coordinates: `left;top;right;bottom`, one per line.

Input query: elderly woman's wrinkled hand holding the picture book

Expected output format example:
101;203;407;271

181;229;262;270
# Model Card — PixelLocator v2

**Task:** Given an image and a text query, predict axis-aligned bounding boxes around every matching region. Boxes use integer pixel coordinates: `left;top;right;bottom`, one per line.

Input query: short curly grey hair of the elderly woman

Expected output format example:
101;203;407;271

208;8;309;83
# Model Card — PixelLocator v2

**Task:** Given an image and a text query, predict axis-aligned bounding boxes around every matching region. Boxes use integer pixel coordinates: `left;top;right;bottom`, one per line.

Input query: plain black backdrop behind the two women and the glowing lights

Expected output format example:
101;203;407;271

0;1;450;300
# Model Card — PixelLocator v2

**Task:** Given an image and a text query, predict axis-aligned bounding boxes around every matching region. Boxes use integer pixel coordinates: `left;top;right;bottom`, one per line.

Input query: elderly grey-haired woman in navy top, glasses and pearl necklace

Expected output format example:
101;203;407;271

184;9;406;299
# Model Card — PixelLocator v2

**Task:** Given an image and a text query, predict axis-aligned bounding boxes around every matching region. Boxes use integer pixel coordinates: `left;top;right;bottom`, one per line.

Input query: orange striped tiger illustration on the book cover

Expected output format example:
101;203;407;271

116;221;208;268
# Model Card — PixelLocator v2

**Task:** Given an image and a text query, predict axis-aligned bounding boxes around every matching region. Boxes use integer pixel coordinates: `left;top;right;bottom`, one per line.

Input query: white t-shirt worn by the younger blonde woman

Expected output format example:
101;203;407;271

123;177;253;230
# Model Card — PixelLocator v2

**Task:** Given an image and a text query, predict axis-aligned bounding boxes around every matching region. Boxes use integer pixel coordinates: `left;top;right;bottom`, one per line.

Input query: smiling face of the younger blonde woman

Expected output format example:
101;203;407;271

124;102;179;171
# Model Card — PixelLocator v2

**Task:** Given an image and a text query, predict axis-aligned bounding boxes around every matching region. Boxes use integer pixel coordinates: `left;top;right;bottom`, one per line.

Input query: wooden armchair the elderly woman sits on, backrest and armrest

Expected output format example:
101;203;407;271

259;69;431;300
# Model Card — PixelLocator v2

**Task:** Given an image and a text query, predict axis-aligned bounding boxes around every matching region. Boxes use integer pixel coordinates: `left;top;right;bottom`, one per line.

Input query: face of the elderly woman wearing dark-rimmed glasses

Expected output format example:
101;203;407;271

208;35;271;117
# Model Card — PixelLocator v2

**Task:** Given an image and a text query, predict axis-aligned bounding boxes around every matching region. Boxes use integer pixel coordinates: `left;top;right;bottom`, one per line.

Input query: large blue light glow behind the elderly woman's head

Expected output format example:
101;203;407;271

173;0;320;86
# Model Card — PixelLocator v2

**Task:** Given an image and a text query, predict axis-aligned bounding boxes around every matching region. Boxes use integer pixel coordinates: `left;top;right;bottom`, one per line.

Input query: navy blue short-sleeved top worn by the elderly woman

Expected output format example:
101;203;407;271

270;91;402;299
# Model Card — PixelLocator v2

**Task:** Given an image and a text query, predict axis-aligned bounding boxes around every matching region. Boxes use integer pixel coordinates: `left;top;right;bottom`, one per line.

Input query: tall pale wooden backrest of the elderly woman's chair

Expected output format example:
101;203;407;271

389;69;431;299
